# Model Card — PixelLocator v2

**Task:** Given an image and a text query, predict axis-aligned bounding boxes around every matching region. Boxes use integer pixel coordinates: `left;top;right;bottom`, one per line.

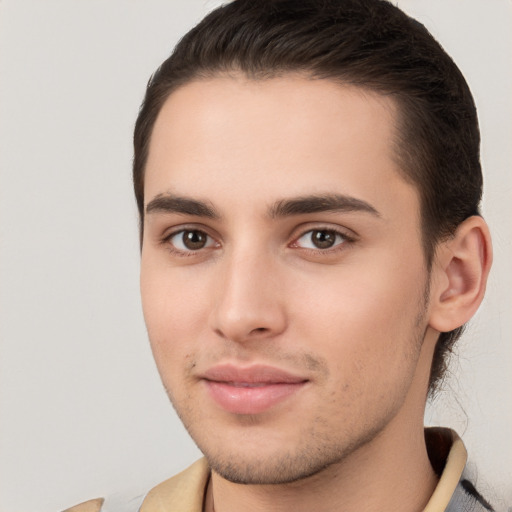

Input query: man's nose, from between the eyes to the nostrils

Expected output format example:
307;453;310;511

210;249;287;342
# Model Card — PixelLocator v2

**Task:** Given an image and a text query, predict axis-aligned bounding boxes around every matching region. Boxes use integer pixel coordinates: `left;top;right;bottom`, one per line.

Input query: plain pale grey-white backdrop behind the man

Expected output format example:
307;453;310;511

0;0;512;512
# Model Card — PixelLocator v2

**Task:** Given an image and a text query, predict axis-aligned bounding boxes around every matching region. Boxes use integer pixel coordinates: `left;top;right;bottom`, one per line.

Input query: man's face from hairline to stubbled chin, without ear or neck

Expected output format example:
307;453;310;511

141;75;436;483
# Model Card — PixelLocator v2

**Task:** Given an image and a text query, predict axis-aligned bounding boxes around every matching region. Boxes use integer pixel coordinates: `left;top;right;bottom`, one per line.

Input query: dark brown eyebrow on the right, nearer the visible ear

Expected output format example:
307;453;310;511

269;194;380;218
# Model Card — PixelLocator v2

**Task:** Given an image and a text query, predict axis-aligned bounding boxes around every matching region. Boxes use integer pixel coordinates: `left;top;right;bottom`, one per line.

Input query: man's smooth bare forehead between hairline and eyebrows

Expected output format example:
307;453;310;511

145;75;414;216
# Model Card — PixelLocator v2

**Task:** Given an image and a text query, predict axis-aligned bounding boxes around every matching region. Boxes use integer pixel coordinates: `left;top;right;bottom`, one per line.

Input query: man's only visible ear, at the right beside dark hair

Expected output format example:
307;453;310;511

429;216;492;332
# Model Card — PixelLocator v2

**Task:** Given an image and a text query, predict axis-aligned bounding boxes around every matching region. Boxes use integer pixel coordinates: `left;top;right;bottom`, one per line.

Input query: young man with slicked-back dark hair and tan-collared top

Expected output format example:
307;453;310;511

67;0;492;512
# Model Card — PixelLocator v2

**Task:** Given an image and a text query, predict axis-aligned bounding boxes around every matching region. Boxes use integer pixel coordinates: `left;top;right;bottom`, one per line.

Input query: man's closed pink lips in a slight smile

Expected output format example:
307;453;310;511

201;365;308;414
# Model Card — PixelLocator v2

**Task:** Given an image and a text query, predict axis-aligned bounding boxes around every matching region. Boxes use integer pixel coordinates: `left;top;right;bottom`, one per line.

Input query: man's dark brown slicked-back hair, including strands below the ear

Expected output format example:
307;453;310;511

133;0;482;395
